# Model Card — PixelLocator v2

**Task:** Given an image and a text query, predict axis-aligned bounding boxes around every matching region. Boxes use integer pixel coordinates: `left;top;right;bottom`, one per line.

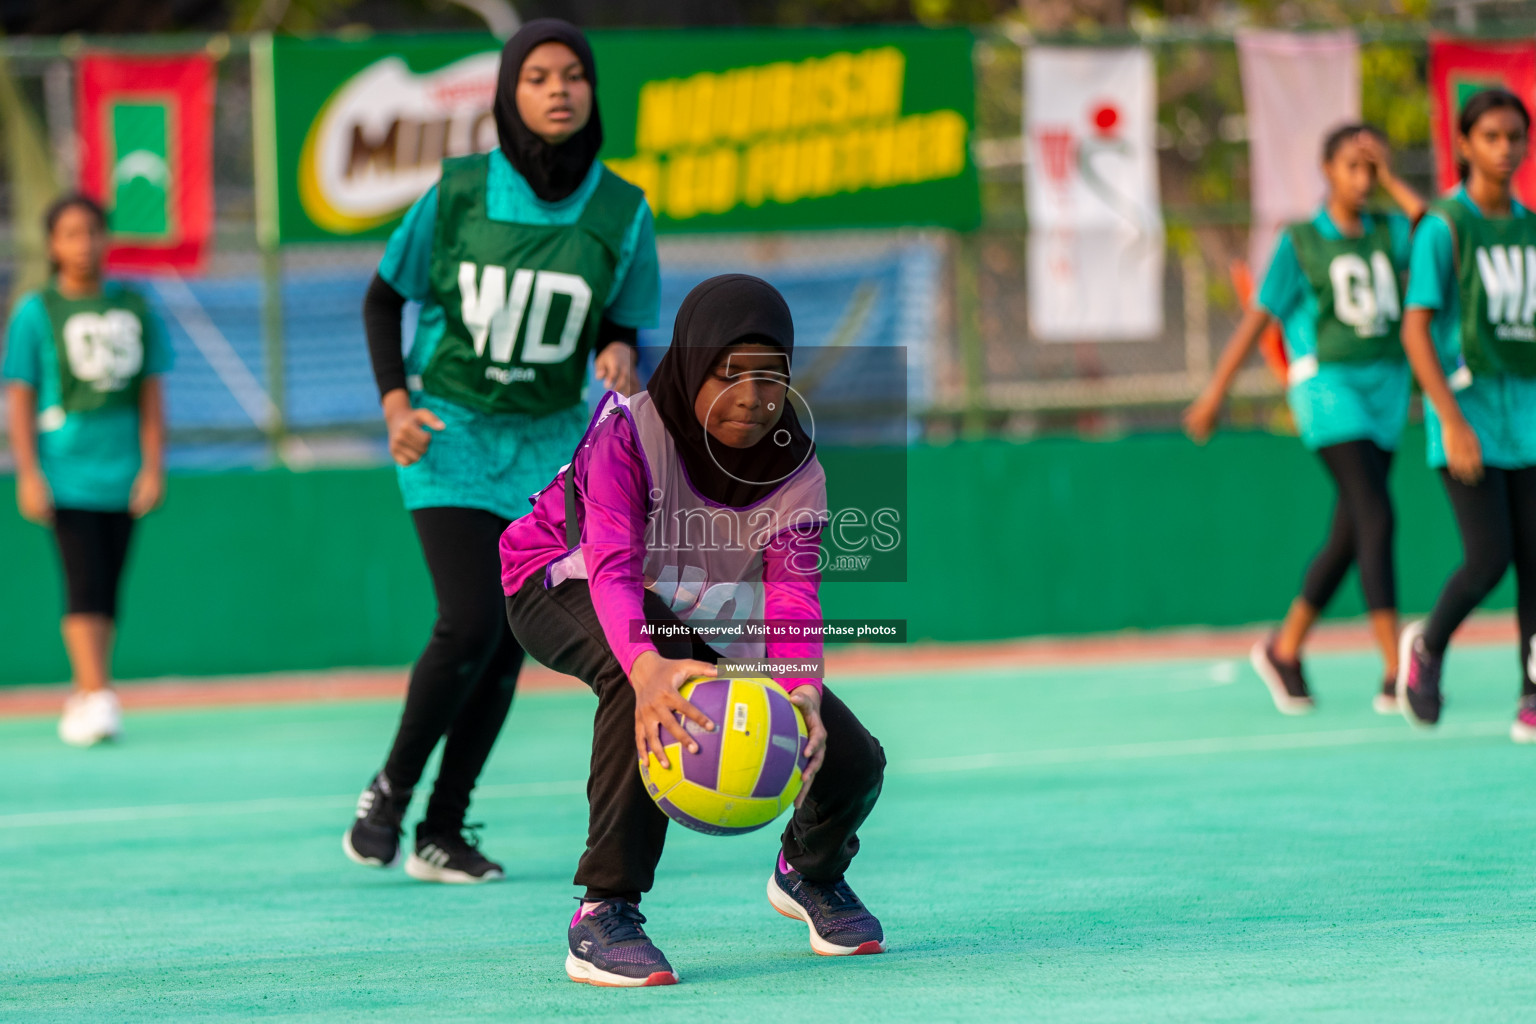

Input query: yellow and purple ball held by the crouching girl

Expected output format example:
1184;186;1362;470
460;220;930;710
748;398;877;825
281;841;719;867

641;679;806;835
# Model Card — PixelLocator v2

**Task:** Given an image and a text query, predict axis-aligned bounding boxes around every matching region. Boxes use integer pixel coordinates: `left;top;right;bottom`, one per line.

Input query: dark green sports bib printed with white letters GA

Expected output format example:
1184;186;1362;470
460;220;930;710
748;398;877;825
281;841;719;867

1286;216;1404;362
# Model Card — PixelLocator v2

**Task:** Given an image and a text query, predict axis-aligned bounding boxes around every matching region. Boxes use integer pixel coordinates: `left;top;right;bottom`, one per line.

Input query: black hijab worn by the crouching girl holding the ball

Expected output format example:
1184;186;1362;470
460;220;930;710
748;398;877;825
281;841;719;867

645;273;816;508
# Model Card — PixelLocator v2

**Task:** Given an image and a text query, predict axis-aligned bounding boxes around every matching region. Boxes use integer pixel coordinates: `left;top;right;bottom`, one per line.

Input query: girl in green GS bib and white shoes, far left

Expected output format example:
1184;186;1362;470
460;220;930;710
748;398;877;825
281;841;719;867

0;195;172;746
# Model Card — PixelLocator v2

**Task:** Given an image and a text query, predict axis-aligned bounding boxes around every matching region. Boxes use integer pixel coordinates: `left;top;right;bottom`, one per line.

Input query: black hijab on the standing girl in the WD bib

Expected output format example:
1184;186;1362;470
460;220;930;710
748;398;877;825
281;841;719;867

492;18;602;203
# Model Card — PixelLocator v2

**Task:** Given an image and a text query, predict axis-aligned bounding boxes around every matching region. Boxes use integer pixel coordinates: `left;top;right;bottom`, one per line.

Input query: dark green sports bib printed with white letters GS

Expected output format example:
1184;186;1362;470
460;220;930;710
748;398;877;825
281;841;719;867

41;284;149;413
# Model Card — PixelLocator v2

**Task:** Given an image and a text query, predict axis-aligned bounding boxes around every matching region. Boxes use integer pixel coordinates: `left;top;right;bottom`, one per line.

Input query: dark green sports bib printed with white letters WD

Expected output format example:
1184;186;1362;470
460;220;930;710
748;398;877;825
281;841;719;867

422;155;645;415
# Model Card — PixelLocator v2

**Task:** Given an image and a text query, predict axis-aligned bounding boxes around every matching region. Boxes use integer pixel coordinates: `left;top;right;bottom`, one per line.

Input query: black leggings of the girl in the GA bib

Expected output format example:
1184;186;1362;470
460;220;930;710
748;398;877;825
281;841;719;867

1301;441;1398;611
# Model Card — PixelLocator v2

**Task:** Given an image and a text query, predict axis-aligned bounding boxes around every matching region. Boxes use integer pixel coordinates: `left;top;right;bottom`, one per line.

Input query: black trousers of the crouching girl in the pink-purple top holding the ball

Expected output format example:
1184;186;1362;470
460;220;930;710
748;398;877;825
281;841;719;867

507;573;885;903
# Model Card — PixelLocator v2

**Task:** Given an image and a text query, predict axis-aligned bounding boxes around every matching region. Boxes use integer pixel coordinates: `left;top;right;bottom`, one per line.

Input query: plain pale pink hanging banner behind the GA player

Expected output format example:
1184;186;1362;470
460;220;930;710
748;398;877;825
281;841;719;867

1238;29;1359;281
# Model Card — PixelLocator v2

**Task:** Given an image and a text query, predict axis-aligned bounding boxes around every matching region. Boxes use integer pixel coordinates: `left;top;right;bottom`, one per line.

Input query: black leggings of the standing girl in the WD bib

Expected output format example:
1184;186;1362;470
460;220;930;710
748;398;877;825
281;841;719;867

384;508;522;835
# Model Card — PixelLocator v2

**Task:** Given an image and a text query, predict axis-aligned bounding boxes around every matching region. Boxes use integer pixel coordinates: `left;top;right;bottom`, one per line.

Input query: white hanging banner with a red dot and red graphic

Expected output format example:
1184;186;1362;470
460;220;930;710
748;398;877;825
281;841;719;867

1025;46;1163;341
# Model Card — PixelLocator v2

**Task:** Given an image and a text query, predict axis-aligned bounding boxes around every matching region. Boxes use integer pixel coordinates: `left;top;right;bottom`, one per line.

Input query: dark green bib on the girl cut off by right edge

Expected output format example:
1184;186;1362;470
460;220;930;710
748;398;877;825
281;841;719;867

1430;198;1536;376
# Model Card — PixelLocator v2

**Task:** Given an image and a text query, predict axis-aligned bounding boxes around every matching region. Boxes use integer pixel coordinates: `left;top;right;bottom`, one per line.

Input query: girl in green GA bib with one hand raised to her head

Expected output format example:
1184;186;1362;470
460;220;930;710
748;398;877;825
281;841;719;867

1184;124;1424;714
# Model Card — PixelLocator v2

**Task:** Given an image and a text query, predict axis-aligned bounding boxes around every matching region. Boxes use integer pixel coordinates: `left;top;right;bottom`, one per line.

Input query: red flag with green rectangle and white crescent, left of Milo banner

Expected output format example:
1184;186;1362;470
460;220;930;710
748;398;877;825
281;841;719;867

75;54;214;270
